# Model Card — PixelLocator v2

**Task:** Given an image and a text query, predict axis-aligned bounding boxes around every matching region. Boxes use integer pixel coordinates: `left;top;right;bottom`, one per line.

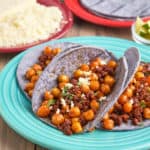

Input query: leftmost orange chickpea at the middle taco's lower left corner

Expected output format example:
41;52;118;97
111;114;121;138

37;105;50;118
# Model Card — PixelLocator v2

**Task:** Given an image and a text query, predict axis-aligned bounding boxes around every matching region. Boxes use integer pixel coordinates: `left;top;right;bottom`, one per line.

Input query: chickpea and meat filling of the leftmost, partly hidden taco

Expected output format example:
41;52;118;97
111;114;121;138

24;46;61;97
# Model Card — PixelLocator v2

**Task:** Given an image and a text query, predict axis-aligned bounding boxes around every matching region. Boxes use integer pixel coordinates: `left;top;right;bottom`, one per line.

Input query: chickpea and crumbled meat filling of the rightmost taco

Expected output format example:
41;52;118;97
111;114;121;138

101;63;150;130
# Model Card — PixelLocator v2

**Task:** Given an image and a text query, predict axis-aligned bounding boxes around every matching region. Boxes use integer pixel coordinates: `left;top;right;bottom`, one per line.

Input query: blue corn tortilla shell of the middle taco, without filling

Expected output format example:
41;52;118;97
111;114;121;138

32;46;128;132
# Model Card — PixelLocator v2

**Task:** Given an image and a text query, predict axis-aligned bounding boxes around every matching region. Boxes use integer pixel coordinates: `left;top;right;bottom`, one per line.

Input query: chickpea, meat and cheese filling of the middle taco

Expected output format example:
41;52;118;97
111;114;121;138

36;57;117;135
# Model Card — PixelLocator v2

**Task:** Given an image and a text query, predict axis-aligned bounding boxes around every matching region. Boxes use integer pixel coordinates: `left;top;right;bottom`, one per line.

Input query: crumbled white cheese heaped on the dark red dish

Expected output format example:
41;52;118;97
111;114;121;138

0;3;63;47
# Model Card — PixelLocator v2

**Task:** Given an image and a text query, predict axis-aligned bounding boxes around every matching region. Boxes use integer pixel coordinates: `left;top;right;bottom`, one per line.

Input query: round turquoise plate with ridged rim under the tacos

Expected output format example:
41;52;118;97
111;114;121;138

0;37;150;150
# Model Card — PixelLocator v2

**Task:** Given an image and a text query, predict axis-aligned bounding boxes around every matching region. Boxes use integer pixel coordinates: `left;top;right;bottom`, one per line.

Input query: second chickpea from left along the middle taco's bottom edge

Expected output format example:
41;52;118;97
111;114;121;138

51;114;65;126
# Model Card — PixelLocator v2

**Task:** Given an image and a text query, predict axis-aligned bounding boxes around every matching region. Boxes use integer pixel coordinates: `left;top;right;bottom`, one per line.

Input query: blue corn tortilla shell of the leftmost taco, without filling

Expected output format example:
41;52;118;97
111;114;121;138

16;42;82;100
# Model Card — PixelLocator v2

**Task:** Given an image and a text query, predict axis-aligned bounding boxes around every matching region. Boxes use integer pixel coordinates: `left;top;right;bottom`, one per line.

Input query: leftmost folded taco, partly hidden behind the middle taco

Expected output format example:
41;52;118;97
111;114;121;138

16;42;81;99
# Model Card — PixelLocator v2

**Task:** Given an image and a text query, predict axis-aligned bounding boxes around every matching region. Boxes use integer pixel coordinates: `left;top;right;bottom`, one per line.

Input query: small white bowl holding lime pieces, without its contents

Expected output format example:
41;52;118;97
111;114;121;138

131;23;150;45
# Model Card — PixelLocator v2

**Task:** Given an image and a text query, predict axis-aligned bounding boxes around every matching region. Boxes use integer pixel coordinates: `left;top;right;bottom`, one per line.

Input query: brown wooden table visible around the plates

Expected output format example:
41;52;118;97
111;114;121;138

0;18;131;150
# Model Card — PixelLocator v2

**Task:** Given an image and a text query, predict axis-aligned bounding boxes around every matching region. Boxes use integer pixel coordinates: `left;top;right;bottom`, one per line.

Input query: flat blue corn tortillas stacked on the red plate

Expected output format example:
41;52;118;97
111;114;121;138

80;0;150;20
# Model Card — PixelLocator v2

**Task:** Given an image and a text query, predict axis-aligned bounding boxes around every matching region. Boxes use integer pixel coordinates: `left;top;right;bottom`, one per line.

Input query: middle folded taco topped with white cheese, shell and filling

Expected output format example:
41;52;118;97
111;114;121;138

32;46;128;135
